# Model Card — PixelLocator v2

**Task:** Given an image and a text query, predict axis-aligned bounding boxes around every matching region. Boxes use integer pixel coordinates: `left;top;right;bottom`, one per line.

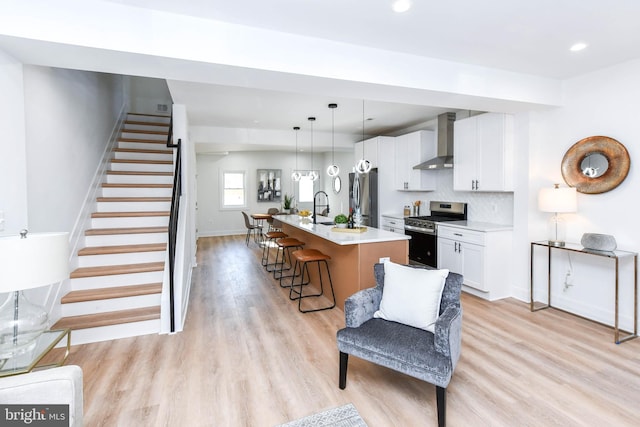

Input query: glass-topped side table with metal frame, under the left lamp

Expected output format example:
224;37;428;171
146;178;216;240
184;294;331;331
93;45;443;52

0;329;71;377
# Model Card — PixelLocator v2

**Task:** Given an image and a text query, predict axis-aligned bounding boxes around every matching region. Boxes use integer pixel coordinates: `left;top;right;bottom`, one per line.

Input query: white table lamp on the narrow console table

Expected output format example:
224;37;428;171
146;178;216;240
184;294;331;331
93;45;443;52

538;184;577;246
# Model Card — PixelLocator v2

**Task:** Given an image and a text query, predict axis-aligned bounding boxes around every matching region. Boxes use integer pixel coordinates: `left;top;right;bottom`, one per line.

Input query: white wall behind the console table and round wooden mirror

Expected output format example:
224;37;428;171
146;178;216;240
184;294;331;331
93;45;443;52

514;61;640;325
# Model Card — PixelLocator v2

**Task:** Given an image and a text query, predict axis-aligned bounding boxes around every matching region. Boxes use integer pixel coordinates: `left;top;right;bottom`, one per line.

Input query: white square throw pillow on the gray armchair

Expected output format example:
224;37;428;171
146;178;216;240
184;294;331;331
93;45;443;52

373;261;449;332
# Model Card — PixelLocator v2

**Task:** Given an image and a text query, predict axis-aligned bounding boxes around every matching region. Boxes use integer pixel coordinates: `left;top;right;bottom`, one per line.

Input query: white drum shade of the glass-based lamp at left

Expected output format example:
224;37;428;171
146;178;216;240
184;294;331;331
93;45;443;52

0;233;69;293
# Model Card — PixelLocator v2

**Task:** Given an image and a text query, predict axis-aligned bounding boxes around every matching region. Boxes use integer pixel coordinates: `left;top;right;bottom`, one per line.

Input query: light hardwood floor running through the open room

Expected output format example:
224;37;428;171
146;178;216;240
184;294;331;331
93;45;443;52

58;236;640;427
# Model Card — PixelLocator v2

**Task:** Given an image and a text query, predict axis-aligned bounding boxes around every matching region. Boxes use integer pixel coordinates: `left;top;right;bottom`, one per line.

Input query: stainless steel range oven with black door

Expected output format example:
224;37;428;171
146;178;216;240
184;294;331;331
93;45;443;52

404;202;467;268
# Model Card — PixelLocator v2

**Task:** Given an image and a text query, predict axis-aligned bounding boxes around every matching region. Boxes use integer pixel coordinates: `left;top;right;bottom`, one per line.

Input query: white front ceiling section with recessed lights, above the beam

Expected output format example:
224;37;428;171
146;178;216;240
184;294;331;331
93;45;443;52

112;0;640;79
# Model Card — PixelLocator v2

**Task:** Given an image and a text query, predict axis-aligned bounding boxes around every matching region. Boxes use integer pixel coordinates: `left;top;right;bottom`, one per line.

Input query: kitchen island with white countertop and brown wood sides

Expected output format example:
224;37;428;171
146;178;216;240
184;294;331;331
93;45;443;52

277;215;409;309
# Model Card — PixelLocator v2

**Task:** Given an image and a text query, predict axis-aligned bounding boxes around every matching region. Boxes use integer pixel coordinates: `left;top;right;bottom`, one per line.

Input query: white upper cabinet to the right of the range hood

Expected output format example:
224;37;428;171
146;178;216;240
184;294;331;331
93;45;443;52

453;113;514;191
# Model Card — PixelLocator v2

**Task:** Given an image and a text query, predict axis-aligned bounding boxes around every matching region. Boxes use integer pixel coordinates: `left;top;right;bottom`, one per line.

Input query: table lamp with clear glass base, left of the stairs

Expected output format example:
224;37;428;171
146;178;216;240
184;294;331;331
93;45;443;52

0;230;69;359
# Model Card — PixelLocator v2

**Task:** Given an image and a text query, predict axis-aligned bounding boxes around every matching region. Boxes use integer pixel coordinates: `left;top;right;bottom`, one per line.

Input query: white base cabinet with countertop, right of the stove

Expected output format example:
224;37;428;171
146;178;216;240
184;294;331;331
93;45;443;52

438;224;512;300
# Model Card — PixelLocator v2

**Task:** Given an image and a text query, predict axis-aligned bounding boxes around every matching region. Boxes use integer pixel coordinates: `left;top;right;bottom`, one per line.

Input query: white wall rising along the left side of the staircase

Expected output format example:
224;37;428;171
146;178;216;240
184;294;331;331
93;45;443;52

24;66;124;231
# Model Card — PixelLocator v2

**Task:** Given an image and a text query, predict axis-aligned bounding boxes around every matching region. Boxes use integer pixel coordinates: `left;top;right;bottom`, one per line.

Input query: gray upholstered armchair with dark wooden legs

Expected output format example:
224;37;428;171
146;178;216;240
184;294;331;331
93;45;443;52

338;264;462;427
